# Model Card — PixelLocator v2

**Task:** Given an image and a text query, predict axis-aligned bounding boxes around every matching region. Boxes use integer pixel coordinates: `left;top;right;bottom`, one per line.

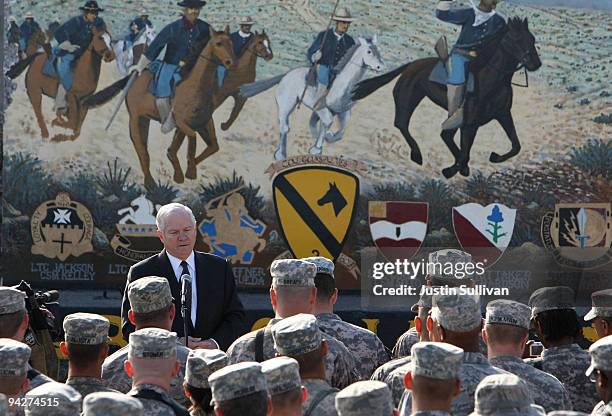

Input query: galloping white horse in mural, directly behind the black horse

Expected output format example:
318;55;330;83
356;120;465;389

240;36;385;160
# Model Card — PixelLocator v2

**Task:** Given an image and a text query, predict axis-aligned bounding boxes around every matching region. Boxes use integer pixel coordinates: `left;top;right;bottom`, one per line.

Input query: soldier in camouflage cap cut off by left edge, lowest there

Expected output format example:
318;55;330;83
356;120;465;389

0;338;32;416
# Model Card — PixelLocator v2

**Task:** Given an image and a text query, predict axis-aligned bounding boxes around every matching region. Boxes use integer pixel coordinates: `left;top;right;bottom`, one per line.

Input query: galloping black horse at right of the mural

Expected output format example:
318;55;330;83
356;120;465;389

353;18;542;178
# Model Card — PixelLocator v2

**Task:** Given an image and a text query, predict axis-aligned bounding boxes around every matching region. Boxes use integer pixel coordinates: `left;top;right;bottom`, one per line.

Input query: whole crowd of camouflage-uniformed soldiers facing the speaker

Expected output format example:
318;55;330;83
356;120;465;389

0;250;612;416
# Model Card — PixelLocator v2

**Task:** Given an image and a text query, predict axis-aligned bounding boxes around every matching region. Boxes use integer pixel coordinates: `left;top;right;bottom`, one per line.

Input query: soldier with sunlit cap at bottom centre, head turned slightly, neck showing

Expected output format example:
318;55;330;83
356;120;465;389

272;314;338;416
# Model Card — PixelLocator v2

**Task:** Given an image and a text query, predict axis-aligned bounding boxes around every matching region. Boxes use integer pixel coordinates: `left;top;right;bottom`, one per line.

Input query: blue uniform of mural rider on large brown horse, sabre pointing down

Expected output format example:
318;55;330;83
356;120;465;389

144;17;210;98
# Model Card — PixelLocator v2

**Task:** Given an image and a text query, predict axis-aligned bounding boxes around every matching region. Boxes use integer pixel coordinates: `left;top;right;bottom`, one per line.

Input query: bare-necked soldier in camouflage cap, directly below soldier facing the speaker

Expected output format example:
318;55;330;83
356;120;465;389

125;328;189;416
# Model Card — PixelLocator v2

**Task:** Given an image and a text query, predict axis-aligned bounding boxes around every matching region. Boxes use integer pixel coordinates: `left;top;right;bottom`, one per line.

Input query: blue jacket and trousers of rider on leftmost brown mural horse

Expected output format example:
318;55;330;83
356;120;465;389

53;15;105;91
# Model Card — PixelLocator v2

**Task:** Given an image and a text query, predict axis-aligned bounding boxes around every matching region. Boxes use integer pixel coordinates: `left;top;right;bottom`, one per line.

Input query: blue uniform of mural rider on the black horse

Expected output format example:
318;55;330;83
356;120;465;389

436;4;506;85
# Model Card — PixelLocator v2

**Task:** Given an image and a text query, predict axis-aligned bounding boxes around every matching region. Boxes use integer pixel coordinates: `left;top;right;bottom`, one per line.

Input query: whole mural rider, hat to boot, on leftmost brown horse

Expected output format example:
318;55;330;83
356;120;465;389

53;0;105;114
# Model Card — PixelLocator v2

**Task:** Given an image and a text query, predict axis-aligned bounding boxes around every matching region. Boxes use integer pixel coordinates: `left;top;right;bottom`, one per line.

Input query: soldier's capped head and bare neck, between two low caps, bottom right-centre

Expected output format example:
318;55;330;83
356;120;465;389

406;342;463;416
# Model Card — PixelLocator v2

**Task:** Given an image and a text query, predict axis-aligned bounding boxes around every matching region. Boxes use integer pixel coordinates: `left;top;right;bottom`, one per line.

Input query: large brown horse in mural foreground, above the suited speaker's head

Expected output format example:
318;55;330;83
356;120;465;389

85;26;236;189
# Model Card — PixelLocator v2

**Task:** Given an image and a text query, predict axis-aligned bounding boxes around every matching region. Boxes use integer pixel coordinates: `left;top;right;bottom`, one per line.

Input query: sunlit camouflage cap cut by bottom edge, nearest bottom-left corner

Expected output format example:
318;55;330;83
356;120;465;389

25;381;82;416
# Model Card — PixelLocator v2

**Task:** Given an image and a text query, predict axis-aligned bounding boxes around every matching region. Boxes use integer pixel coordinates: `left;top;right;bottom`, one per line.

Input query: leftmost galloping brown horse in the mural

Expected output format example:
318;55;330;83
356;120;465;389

7;27;115;142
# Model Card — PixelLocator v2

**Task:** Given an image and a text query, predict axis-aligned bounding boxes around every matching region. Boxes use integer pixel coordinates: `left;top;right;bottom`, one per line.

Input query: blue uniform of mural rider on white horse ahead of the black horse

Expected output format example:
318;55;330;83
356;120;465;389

306;29;355;86
